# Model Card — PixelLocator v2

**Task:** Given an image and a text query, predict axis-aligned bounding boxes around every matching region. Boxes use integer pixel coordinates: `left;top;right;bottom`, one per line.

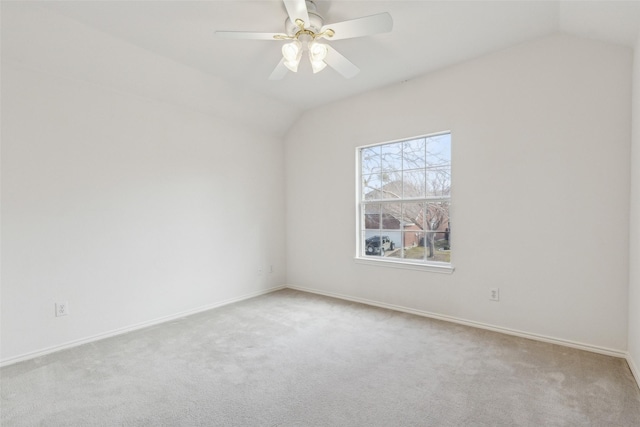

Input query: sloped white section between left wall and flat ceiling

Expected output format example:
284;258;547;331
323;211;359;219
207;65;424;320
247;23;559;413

0;2;297;134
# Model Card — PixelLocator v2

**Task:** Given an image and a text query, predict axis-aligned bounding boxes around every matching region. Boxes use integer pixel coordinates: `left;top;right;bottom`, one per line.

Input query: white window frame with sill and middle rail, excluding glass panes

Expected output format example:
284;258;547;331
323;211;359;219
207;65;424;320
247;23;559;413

354;131;455;274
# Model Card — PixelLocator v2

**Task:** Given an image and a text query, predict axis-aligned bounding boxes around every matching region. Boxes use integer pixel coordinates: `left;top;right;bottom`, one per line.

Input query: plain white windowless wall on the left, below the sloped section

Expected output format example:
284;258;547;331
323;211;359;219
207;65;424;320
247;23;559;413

0;5;285;363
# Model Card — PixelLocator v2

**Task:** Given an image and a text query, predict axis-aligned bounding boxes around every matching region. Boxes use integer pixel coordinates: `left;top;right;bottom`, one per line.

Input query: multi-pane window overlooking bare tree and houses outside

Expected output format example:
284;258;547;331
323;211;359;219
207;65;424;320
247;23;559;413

357;132;451;266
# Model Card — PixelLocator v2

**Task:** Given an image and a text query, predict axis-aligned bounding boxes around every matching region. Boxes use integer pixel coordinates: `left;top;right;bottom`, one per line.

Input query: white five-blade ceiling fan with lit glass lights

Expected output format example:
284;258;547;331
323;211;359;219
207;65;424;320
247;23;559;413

216;0;393;80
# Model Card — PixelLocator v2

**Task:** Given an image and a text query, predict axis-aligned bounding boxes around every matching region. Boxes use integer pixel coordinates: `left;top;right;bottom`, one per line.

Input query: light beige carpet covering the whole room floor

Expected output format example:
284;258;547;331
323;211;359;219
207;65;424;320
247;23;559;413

0;290;640;427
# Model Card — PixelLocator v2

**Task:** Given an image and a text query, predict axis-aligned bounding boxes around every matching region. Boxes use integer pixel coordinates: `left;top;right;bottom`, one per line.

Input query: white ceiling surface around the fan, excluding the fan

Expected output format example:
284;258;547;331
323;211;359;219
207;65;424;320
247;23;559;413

16;0;640;110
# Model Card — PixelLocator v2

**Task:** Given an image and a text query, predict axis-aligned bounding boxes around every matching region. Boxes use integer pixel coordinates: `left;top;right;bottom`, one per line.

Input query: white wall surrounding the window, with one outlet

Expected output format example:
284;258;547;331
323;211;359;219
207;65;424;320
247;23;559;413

286;35;632;352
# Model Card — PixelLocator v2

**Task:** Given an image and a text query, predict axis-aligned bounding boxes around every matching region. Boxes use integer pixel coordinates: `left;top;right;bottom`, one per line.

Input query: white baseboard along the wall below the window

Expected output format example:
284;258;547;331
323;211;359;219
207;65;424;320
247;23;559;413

285;285;628;362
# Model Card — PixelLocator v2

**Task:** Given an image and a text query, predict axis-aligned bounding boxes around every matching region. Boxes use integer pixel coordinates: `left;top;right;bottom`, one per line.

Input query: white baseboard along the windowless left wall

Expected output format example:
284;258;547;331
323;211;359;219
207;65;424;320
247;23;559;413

0;286;285;367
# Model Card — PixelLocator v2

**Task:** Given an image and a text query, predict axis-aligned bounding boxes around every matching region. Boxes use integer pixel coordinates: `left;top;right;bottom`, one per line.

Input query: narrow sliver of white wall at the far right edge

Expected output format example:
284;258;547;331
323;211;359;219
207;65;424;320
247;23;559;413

629;36;640;383
